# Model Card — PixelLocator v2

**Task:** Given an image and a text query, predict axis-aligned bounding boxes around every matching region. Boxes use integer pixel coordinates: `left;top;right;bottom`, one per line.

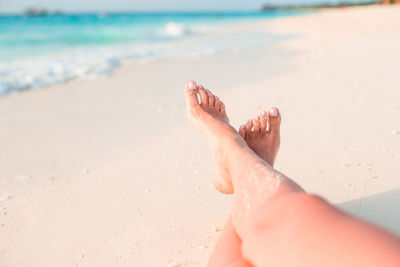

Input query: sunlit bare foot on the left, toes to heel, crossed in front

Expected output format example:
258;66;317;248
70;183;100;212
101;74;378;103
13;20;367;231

185;81;247;194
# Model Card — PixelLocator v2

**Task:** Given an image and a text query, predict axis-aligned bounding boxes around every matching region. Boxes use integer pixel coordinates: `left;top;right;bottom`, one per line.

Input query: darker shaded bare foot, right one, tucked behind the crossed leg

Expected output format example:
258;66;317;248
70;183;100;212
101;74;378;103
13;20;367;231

239;107;281;167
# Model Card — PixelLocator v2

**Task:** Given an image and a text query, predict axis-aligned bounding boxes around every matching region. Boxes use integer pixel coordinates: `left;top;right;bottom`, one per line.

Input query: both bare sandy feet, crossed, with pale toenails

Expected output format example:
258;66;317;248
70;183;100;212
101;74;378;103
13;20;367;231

185;81;281;194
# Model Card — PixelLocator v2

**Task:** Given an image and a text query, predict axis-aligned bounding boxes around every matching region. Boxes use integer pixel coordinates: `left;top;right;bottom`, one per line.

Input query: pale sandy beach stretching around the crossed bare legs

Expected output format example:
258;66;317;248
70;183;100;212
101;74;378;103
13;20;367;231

0;6;400;267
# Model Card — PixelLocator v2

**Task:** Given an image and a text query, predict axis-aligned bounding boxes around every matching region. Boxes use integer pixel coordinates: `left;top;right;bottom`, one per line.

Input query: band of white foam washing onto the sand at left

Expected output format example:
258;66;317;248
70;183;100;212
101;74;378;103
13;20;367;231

0;47;152;95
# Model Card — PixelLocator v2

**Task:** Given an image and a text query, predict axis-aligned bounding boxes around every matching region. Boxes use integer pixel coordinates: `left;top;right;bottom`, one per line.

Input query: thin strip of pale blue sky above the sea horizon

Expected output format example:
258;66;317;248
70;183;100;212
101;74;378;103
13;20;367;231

0;0;374;13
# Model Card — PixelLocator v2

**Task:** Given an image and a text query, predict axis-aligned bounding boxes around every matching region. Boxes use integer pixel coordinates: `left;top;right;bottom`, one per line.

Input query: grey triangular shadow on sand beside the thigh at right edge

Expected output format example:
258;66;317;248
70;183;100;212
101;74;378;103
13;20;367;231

335;189;400;234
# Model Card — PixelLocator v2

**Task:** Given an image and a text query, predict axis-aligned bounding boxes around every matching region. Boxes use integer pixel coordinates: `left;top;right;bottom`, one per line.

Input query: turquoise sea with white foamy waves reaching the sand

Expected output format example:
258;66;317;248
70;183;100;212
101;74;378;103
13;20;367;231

0;11;301;95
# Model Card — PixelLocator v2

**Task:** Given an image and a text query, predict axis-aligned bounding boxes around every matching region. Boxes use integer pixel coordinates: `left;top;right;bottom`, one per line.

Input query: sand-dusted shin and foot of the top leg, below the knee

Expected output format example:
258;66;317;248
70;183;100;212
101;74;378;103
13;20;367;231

185;82;303;238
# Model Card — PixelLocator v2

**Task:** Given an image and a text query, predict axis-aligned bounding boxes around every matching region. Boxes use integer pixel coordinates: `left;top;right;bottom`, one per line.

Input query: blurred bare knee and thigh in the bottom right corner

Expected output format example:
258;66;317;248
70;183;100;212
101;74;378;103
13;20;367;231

242;193;400;267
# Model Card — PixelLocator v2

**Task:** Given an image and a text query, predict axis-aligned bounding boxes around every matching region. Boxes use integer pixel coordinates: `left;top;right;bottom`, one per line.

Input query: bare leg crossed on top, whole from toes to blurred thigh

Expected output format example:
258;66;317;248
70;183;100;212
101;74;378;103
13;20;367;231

185;83;400;266
